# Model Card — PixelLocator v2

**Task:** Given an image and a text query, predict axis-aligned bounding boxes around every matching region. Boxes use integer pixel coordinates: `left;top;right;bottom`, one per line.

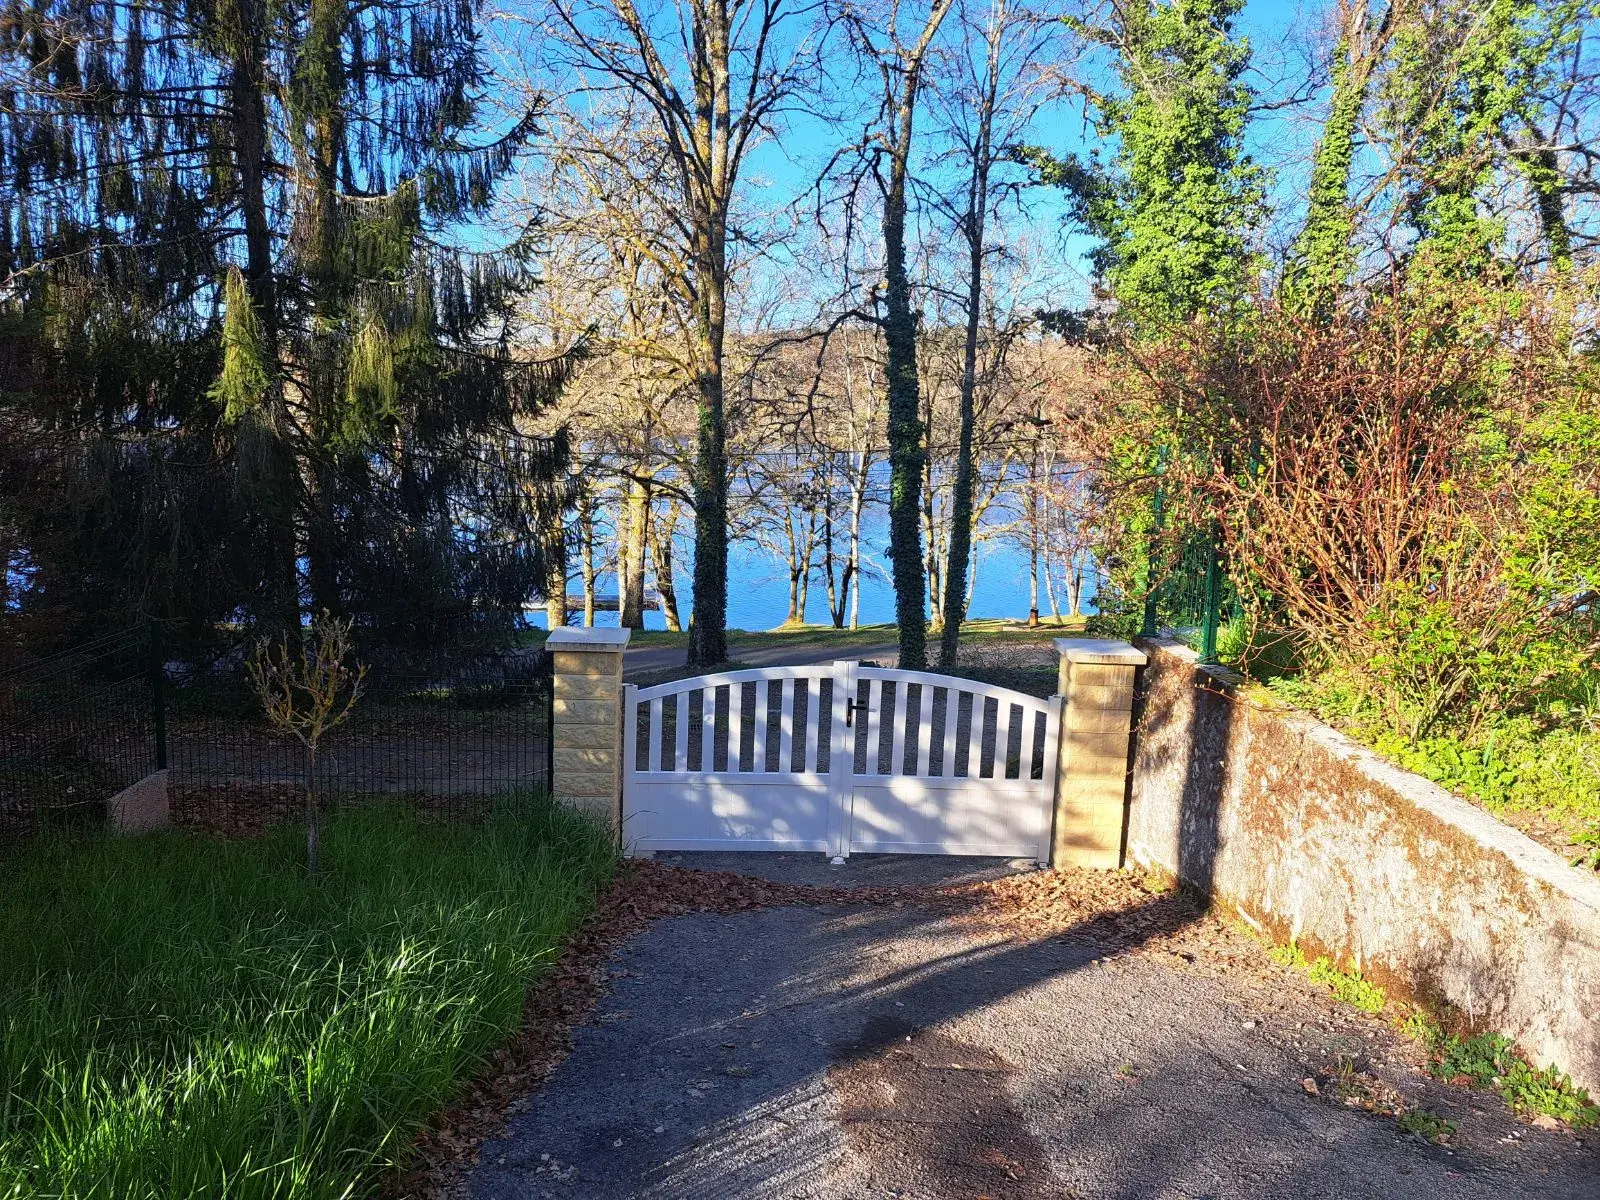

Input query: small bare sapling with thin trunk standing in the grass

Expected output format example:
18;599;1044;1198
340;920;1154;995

246;611;366;875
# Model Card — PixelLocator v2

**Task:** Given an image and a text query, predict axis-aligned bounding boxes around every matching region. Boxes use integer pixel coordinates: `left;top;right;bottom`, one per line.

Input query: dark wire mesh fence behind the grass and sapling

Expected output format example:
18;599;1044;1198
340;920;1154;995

0;626;550;835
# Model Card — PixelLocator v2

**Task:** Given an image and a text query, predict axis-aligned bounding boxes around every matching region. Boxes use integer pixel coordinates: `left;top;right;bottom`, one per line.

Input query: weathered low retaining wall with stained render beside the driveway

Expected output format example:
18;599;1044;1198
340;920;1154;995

1128;640;1600;1090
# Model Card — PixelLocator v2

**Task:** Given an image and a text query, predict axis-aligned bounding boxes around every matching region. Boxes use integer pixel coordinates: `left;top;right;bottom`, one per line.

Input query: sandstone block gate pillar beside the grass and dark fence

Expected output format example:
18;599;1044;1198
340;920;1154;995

544;626;629;834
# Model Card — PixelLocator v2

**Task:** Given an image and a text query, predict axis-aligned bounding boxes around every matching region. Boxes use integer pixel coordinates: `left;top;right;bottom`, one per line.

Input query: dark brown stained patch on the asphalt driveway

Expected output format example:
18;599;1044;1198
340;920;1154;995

829;1018;1062;1200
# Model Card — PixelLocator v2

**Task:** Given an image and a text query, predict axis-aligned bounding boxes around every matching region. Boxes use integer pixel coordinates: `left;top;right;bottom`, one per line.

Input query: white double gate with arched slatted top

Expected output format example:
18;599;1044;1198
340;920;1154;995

622;662;1062;862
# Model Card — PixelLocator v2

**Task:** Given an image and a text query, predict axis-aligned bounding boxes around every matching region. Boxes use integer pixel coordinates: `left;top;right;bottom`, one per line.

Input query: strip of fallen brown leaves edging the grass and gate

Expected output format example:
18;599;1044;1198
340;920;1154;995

390;859;1246;1200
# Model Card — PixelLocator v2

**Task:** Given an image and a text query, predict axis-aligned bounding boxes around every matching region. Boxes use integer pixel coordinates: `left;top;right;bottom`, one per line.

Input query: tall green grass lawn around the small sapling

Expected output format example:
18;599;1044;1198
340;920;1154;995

0;800;611;1200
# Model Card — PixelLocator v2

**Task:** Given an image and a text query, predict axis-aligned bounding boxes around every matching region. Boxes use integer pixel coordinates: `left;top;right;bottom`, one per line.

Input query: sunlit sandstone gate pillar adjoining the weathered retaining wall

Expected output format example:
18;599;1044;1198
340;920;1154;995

1050;637;1146;869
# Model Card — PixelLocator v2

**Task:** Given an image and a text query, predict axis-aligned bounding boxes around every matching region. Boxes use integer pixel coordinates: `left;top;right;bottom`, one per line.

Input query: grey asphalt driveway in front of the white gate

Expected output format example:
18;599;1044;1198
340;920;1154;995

469;854;1600;1200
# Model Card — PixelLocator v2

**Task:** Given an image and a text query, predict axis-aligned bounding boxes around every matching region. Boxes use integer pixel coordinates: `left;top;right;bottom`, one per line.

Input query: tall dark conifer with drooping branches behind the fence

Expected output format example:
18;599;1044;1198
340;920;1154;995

0;0;565;649
